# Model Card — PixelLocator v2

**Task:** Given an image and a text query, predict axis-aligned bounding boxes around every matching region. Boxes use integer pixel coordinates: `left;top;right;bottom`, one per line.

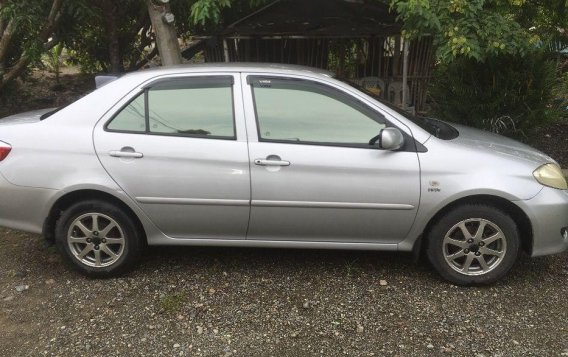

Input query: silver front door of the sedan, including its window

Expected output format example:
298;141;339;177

245;76;420;243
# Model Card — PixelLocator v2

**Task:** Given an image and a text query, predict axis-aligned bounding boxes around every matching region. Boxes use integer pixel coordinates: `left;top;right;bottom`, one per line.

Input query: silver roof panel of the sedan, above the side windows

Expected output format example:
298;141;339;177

127;62;334;77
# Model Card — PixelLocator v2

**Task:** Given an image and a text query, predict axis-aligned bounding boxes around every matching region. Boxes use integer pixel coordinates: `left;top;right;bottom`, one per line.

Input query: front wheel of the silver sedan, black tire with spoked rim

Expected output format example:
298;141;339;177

426;205;520;286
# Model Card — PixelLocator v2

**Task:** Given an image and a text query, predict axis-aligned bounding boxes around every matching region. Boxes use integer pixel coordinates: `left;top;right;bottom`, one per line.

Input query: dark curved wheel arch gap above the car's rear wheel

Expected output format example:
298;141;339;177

42;189;147;243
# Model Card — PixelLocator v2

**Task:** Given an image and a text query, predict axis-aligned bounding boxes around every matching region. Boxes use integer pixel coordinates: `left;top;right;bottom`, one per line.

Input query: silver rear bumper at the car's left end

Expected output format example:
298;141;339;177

0;174;58;234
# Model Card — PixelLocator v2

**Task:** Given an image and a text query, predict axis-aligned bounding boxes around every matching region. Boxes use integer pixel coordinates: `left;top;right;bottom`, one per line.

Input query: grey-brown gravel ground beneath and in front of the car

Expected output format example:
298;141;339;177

0;229;568;356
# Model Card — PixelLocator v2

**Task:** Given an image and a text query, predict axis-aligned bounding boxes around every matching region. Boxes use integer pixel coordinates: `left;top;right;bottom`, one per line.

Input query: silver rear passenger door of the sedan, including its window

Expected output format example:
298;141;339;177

94;73;250;239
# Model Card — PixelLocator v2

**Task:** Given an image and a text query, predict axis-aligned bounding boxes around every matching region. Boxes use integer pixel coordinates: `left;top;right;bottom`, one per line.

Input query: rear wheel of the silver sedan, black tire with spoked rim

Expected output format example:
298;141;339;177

55;200;144;278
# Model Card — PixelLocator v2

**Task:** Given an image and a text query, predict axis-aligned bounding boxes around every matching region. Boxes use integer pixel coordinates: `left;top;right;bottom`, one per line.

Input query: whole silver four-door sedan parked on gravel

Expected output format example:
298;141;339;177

0;64;568;285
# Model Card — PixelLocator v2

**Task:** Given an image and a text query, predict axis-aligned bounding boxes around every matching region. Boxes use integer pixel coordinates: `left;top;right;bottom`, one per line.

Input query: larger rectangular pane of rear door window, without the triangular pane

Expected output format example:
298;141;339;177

148;80;235;137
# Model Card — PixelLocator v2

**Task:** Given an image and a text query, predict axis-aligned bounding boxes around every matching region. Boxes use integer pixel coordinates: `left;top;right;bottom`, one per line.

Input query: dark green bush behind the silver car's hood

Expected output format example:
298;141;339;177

430;52;568;133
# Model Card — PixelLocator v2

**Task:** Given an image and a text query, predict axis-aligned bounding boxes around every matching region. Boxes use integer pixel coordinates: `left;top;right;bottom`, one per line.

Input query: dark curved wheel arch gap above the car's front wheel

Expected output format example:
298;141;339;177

422;195;533;255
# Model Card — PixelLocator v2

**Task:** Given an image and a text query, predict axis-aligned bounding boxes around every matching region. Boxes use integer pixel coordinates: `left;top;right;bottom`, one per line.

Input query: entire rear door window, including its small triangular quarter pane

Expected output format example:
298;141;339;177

107;77;235;139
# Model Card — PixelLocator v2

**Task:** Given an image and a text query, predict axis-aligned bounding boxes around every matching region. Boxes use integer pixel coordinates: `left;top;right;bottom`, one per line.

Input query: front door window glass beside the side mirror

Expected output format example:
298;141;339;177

251;77;385;146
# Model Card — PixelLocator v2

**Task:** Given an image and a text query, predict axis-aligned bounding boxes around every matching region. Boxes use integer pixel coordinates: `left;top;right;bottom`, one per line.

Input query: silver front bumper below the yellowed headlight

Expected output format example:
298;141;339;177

513;187;568;257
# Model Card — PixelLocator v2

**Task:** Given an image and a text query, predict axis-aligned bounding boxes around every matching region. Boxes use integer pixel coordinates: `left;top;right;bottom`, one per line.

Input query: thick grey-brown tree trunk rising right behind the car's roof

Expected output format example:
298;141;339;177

146;0;181;66
